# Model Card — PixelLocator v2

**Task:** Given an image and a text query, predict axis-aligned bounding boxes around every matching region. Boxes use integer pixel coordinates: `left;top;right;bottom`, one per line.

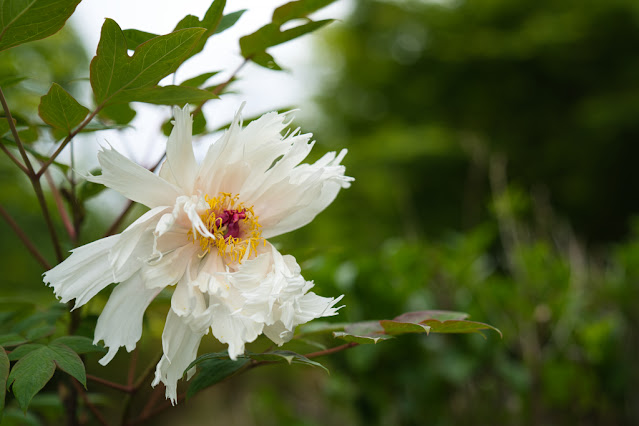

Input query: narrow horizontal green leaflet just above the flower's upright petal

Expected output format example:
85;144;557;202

118;86;217;106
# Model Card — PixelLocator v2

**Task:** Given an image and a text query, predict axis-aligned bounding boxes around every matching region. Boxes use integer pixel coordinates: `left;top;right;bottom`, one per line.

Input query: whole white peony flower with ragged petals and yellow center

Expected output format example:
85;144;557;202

44;107;352;402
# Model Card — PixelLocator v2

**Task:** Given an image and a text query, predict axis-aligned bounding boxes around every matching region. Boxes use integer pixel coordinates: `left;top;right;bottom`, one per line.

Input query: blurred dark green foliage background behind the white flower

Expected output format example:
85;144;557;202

0;0;639;426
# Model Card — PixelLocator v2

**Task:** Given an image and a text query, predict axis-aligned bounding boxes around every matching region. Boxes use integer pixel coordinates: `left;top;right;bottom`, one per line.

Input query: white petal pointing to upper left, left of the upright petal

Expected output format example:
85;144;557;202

87;147;184;208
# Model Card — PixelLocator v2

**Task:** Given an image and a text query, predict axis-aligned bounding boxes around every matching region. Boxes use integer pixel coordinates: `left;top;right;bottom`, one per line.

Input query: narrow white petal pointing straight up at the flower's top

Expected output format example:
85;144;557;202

160;105;197;194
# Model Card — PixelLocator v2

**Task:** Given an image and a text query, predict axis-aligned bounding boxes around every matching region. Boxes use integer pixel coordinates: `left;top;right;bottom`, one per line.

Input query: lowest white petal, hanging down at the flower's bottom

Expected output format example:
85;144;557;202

152;309;206;404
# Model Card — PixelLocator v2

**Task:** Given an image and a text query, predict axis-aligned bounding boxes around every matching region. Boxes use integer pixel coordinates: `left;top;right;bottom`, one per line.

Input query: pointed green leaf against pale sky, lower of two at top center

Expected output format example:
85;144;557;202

240;19;333;59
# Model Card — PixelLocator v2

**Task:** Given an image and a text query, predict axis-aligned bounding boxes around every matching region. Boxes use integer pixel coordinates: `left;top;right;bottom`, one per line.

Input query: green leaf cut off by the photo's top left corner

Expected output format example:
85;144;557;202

0;0;80;51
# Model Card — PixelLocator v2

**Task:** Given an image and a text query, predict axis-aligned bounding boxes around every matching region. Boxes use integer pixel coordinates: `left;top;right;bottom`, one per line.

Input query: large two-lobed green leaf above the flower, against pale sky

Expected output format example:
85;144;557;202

90;19;206;105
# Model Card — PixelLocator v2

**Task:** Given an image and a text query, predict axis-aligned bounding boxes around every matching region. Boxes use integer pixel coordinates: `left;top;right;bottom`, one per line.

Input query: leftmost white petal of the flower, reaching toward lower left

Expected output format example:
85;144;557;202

44;235;140;309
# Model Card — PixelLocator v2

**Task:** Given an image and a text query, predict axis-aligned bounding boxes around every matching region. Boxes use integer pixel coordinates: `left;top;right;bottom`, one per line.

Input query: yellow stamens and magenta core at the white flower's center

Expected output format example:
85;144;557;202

195;192;266;263
